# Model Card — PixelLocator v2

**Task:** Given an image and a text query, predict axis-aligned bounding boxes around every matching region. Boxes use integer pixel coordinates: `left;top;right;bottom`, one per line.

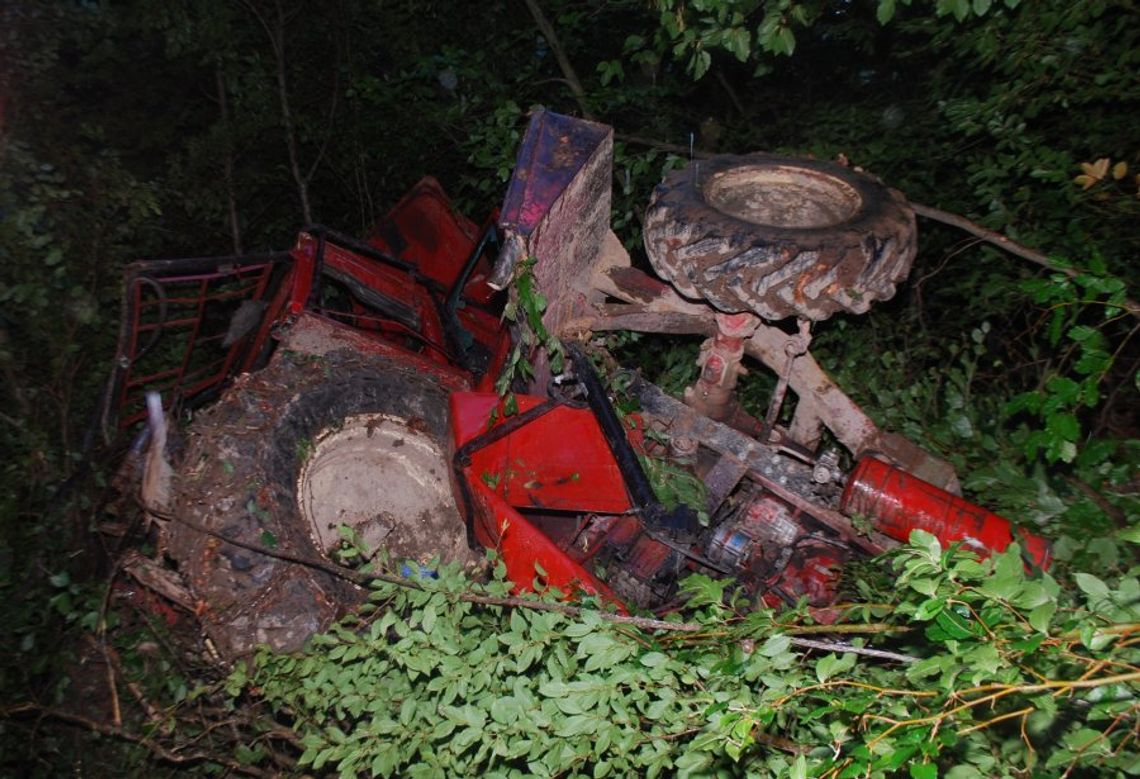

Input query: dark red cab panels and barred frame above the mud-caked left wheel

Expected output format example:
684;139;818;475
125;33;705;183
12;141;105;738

103;178;510;432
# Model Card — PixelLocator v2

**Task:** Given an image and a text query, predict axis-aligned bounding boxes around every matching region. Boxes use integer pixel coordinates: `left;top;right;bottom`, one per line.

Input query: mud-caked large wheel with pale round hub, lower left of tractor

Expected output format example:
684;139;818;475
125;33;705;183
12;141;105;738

166;349;475;658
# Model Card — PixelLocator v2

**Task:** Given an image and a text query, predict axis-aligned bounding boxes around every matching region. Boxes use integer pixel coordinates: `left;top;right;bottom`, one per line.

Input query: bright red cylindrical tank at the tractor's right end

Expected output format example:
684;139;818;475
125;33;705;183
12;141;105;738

839;457;1050;568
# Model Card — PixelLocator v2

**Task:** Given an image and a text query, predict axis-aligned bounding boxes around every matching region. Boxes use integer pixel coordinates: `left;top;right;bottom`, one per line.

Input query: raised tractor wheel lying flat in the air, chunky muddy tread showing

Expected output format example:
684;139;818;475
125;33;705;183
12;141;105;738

645;154;917;320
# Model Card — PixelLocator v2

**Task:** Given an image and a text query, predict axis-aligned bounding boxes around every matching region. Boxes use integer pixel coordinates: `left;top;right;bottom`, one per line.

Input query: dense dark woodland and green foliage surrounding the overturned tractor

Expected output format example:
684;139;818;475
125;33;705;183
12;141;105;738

0;0;1140;777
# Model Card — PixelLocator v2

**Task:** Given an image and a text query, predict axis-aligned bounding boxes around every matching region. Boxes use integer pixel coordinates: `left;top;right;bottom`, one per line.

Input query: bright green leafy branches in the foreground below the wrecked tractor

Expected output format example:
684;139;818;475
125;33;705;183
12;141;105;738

227;533;1140;779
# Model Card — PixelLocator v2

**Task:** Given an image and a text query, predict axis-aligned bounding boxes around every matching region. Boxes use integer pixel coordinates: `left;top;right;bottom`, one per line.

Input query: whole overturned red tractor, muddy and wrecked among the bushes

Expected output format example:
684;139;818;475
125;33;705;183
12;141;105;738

107;111;1049;657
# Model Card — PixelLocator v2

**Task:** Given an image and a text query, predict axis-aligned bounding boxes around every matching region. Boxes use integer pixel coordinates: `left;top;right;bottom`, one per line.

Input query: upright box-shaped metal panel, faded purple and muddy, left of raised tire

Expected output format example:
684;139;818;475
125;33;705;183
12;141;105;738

491;108;613;333
